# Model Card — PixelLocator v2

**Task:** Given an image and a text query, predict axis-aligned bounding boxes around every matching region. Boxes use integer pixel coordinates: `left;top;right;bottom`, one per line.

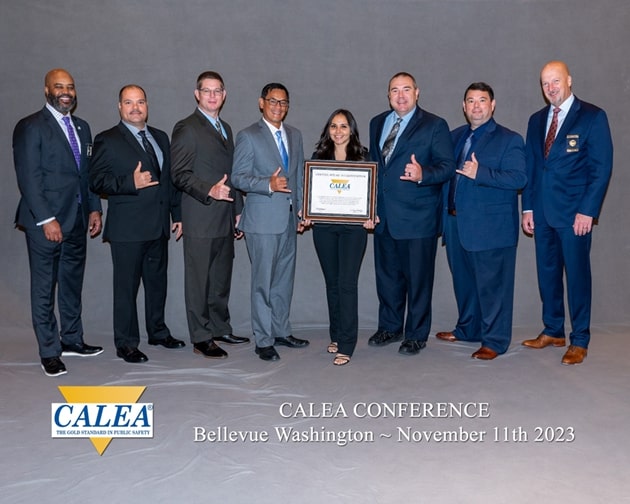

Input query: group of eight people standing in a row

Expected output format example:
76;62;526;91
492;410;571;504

13;61;612;376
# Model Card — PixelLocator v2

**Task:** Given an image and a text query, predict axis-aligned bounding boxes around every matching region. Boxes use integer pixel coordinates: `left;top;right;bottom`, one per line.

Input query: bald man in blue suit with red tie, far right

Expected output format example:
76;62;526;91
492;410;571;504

522;61;613;365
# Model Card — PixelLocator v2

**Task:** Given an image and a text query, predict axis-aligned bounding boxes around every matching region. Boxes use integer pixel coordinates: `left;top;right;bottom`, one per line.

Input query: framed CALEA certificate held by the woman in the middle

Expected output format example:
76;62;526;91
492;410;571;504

302;160;377;224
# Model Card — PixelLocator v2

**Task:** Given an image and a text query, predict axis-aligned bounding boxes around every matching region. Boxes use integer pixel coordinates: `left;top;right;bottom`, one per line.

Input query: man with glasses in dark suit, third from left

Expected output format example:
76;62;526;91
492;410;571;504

171;71;249;359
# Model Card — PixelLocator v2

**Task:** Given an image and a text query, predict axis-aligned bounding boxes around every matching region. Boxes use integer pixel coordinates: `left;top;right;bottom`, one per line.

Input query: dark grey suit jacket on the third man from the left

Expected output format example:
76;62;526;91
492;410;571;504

171;109;243;238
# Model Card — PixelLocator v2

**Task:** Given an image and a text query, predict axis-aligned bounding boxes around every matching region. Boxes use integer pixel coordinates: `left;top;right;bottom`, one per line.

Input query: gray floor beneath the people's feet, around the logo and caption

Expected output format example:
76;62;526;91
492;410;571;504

0;327;630;504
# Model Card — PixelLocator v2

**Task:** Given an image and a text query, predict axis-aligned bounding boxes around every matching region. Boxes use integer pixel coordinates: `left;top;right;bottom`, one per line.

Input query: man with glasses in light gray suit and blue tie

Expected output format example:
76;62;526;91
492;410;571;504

232;83;309;361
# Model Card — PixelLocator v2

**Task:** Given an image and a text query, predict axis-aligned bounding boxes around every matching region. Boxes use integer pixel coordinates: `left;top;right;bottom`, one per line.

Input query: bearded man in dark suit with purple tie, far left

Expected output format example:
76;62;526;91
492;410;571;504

13;68;103;376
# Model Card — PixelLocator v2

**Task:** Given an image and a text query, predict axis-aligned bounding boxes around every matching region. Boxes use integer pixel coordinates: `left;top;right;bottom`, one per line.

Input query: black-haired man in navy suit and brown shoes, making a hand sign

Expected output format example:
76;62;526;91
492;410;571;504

436;82;527;360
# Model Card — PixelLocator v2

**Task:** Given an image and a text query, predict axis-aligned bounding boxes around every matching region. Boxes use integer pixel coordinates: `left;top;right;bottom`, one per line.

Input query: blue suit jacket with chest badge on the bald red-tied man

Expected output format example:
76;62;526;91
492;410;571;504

523;97;613;227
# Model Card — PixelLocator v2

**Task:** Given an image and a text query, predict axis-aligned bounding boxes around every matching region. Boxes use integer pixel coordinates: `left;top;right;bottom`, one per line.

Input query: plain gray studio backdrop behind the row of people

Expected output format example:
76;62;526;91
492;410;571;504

0;0;630;342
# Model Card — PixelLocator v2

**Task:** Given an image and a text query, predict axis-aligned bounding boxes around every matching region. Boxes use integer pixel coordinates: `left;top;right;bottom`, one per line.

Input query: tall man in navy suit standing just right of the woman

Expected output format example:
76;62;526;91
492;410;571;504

368;72;455;355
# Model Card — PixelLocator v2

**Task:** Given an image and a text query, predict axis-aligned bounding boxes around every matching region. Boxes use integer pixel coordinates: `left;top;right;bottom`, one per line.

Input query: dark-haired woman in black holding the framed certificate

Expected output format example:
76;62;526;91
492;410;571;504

312;109;374;366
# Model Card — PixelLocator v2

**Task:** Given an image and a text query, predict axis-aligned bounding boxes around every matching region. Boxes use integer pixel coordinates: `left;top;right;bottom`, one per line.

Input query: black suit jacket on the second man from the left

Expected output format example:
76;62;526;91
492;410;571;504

90;122;181;242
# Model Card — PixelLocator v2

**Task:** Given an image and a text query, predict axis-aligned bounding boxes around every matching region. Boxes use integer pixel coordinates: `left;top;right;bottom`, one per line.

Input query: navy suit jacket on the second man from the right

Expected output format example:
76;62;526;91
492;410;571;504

442;119;527;252
